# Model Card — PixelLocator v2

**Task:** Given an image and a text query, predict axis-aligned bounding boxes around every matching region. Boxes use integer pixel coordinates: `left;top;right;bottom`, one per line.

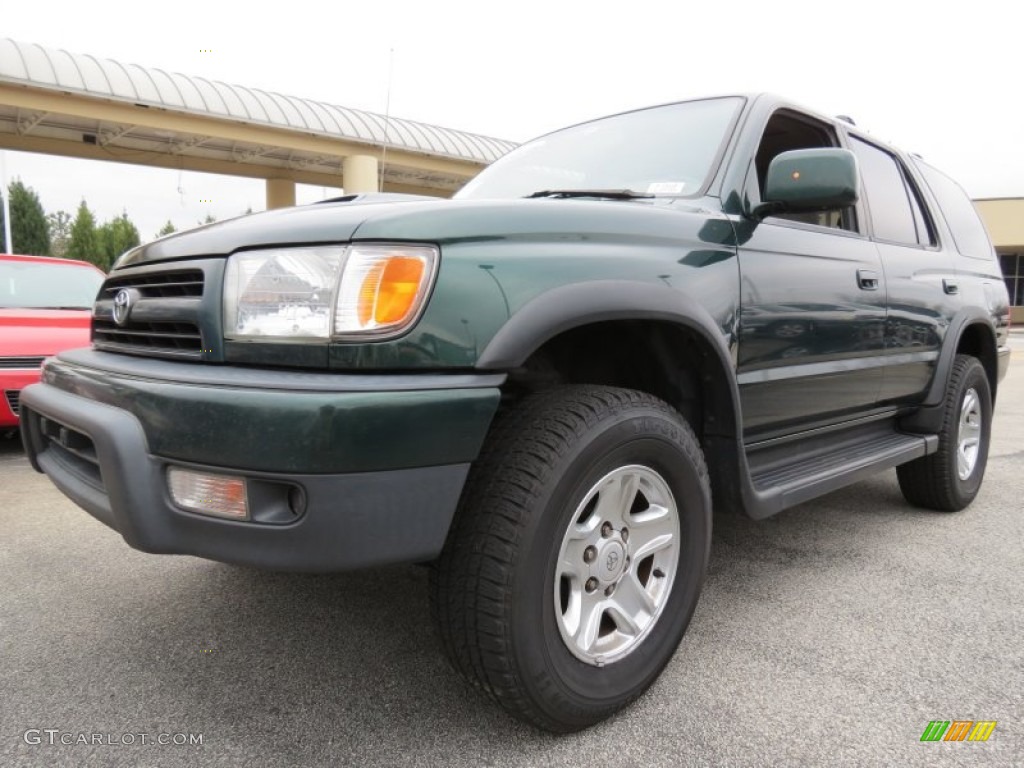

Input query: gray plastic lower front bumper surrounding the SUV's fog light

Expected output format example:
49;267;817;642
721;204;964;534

22;384;469;571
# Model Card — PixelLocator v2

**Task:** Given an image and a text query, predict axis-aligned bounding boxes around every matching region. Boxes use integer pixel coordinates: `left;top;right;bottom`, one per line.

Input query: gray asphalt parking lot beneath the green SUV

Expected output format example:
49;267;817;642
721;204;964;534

0;336;1024;768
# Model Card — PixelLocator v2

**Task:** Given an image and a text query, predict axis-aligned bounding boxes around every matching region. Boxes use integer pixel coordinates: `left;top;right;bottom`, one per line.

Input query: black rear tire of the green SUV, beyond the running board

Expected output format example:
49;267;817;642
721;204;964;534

896;354;992;512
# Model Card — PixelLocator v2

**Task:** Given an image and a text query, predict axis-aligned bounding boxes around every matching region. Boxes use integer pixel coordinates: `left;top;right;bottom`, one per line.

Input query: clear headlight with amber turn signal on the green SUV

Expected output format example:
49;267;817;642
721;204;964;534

224;245;438;341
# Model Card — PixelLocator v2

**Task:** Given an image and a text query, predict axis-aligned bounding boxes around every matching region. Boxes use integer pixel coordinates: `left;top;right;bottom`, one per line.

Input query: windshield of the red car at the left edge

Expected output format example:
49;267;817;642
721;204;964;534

0;259;103;309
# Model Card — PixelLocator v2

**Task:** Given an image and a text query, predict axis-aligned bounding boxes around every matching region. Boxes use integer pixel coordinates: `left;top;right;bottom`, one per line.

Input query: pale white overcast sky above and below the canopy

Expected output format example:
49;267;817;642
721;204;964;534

0;0;1024;240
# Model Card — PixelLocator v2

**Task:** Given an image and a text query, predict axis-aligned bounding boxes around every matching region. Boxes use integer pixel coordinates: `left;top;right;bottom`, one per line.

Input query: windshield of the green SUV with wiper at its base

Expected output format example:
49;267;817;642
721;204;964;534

455;96;742;200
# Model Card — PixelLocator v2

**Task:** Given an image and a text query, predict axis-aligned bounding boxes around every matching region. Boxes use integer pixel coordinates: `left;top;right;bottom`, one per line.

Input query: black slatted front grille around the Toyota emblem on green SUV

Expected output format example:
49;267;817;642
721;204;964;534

92;269;204;358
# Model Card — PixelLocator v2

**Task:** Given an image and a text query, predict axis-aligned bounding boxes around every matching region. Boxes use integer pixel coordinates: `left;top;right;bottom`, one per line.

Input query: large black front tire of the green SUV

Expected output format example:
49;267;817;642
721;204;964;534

431;386;712;732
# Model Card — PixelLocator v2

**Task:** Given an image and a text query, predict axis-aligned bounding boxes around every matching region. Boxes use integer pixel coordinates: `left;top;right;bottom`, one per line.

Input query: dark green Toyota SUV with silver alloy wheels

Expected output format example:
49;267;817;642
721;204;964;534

22;95;1009;731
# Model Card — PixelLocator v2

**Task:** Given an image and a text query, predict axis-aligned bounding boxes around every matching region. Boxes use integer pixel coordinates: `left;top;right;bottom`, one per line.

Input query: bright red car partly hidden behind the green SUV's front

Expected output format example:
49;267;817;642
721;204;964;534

0;254;103;431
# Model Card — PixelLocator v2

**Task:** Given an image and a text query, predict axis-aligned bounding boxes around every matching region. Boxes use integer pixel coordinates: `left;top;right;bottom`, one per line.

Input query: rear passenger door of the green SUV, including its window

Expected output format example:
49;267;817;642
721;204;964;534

849;135;959;403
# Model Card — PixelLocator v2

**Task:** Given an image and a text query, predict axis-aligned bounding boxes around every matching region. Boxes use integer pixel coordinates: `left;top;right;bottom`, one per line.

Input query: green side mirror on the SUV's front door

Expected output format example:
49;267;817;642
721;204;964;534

752;148;860;219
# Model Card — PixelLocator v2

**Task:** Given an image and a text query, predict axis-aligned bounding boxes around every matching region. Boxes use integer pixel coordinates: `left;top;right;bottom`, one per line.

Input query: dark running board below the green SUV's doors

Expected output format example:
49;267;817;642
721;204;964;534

746;419;939;517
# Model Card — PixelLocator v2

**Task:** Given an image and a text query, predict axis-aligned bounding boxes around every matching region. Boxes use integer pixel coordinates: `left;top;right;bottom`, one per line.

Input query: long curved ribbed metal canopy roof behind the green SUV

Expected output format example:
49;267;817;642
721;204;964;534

0;38;516;195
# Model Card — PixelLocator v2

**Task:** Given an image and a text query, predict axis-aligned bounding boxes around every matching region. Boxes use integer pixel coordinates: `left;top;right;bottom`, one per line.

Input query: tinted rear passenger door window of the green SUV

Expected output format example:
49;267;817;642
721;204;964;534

850;137;934;246
